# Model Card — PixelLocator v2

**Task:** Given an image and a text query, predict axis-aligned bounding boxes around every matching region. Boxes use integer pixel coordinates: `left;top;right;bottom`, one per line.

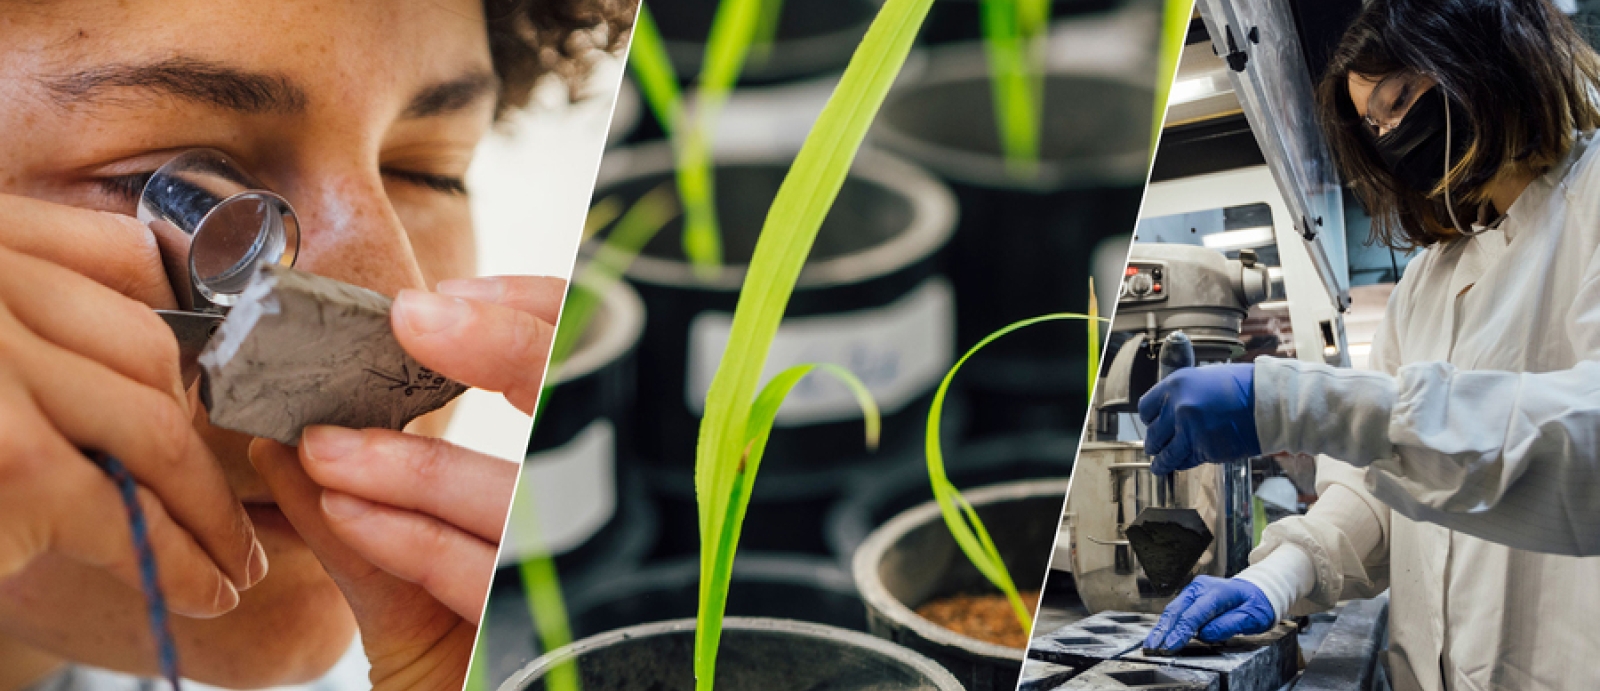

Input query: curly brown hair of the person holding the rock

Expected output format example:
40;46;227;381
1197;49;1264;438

483;0;638;118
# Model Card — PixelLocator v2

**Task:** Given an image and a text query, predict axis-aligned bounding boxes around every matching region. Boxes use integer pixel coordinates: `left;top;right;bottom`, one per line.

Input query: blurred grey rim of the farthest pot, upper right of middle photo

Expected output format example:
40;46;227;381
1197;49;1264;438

867;45;1154;192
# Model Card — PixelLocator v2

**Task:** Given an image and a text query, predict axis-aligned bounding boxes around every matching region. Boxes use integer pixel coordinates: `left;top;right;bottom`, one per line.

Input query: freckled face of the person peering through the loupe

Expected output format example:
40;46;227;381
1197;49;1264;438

0;0;498;685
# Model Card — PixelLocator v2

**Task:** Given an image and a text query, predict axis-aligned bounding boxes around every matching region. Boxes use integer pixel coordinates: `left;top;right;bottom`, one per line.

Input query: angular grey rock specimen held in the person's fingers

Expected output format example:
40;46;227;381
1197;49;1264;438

200;264;467;445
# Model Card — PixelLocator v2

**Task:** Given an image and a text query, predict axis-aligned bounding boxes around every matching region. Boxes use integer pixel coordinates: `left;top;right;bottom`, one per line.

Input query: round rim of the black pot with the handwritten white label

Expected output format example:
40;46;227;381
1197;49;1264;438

584;141;957;293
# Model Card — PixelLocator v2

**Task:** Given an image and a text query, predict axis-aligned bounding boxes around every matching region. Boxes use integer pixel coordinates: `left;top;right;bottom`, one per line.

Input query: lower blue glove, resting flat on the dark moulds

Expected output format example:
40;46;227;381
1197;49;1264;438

1144;576;1278;653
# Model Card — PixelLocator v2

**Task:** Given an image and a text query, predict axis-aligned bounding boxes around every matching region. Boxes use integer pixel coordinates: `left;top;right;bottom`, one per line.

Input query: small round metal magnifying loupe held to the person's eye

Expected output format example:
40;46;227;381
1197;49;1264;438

138;149;299;385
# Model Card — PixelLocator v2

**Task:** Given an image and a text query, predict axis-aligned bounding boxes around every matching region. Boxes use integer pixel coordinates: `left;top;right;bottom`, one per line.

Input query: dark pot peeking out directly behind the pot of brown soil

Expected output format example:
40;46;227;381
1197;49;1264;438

827;432;1078;568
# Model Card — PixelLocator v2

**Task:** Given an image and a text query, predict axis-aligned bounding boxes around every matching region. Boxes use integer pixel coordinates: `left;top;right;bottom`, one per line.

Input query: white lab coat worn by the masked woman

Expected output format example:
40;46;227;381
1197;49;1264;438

1251;134;1600;691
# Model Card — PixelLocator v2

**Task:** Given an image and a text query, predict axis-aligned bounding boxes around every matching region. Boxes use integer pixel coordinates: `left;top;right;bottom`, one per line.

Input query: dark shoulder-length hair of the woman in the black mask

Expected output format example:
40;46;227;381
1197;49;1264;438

1317;0;1600;248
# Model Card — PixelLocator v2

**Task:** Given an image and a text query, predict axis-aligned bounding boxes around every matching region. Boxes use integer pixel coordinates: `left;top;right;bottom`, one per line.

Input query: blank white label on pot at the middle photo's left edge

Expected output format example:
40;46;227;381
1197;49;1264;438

499;417;616;566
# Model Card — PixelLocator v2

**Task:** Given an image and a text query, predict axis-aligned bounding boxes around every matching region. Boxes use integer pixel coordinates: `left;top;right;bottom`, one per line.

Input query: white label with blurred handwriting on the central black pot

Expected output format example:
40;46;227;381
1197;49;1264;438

683;278;955;427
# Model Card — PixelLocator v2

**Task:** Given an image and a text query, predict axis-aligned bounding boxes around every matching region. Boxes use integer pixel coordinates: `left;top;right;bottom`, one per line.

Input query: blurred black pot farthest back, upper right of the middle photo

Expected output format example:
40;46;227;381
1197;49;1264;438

874;49;1154;435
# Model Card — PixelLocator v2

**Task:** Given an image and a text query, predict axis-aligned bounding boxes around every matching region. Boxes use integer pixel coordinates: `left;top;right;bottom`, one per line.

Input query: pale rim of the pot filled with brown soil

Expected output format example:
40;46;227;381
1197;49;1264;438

850;478;1072;662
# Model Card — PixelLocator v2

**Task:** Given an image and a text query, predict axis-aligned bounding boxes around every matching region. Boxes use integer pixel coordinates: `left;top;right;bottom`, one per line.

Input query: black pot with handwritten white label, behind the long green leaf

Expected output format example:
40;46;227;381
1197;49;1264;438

586;144;955;553
